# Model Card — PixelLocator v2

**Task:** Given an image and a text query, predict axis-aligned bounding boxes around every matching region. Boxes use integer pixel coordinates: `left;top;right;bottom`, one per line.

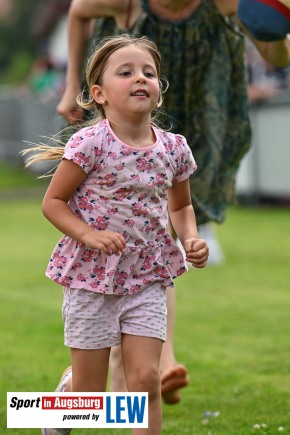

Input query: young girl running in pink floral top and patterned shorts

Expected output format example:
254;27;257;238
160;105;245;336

27;35;208;435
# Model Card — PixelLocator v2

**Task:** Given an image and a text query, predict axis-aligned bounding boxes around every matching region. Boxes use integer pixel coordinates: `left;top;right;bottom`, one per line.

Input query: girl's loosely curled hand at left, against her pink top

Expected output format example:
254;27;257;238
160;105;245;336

83;230;126;255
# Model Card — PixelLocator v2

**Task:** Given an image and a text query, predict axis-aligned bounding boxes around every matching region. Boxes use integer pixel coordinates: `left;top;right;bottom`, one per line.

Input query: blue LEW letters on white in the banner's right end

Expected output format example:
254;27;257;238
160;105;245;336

105;393;148;425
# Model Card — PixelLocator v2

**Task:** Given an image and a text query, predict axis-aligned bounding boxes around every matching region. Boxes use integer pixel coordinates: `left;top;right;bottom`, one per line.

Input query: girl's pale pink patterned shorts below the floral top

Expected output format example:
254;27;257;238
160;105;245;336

62;284;167;349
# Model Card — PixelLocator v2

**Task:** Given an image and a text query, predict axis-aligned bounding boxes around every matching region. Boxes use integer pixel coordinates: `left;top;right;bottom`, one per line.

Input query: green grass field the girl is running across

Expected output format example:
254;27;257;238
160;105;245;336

0;192;290;435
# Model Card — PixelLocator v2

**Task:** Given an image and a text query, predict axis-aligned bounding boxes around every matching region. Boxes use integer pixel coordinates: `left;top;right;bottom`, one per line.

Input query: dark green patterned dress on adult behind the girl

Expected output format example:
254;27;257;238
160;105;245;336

91;0;251;224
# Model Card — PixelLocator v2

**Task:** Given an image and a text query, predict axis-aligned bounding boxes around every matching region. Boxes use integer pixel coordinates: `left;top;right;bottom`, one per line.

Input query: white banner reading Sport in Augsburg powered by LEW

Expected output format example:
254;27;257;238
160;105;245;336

7;393;148;429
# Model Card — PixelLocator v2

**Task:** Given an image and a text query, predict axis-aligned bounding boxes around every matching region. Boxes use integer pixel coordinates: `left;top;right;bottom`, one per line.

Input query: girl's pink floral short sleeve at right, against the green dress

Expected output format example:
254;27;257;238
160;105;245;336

173;135;197;183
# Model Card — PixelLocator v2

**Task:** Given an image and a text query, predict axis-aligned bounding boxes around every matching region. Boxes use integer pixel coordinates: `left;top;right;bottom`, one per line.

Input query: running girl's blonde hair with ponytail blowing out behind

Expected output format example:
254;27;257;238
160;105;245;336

22;34;168;171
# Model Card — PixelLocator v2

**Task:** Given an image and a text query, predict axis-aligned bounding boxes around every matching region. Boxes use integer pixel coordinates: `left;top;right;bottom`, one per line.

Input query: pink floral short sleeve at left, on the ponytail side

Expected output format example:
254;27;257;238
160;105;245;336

63;127;103;174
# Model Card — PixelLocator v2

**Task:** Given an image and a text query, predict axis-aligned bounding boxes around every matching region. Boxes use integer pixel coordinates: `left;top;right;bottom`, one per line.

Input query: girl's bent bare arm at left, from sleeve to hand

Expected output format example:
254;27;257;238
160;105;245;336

42;159;125;255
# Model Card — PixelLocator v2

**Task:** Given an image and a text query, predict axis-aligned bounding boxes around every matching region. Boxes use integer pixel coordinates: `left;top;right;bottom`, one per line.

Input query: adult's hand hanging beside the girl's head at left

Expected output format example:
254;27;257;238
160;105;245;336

56;88;84;124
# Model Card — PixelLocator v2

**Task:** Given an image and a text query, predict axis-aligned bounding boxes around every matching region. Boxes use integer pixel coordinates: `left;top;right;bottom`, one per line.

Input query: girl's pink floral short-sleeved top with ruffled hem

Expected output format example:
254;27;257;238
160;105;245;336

46;120;196;295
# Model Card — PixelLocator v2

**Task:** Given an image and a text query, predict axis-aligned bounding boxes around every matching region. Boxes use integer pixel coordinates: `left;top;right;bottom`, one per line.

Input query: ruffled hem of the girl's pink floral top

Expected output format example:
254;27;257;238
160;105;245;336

46;234;188;295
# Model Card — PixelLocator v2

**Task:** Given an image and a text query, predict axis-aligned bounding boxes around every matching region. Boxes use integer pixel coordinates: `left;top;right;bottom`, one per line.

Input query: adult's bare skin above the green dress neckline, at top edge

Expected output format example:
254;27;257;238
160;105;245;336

149;0;202;20
